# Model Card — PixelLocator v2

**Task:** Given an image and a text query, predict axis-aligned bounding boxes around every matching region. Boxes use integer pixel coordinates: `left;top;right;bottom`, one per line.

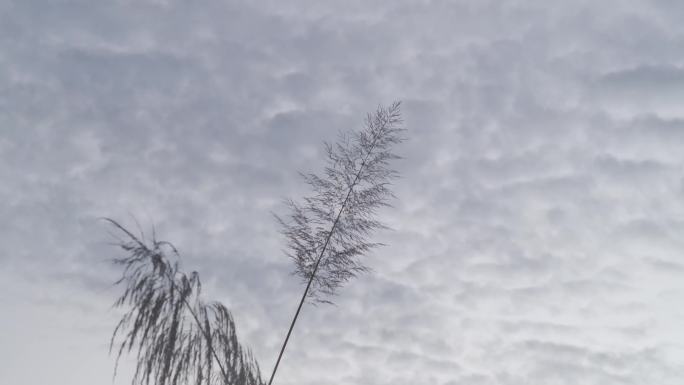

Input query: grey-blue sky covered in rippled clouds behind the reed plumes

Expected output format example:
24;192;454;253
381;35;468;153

0;0;684;385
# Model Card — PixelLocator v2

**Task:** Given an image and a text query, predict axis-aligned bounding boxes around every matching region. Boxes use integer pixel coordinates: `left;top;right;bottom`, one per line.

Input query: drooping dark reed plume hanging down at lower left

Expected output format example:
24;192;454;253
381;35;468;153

105;218;263;385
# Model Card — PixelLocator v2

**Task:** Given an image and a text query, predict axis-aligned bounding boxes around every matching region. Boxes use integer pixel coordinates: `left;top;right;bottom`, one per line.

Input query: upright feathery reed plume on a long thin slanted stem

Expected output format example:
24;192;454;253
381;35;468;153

269;102;405;385
